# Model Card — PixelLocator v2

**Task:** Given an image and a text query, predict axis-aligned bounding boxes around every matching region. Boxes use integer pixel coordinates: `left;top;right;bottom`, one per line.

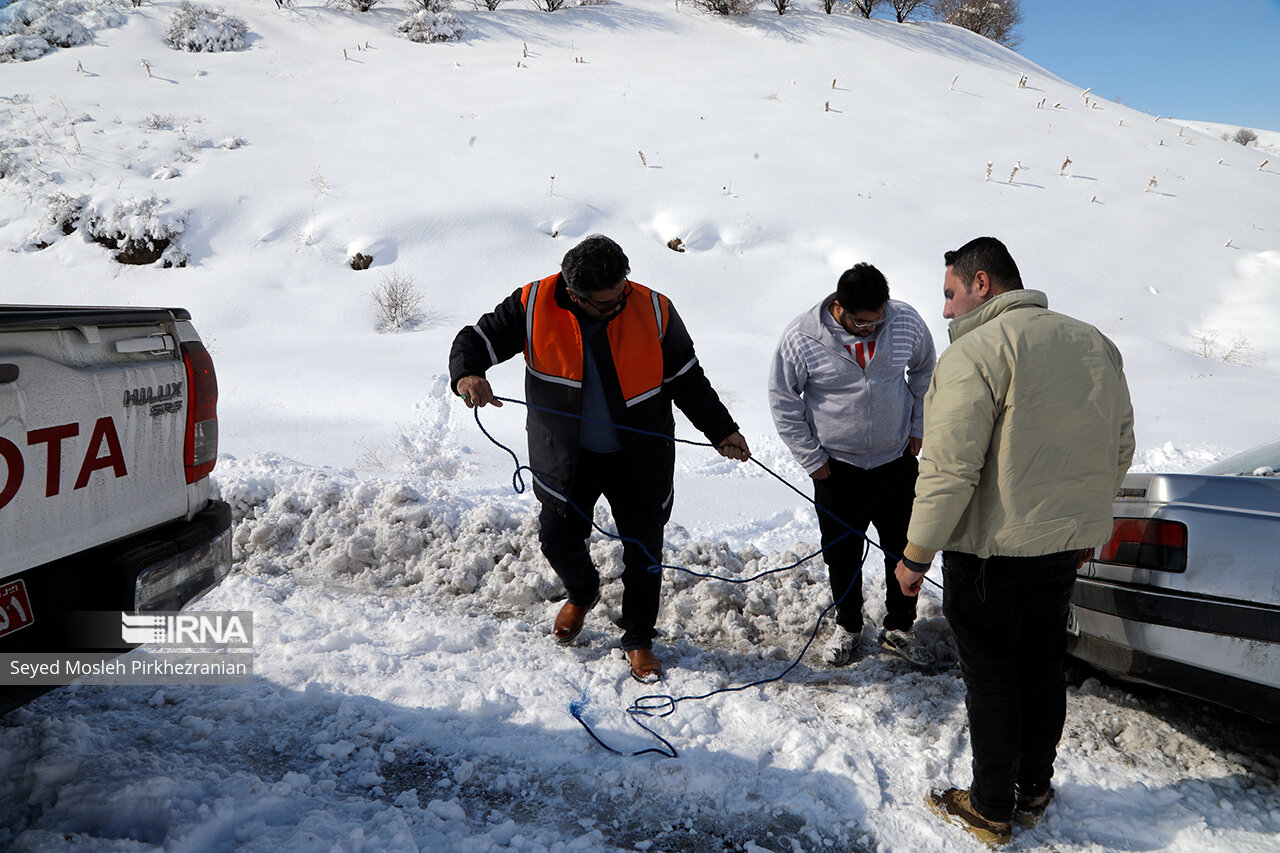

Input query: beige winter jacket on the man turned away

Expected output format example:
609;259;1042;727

905;291;1134;564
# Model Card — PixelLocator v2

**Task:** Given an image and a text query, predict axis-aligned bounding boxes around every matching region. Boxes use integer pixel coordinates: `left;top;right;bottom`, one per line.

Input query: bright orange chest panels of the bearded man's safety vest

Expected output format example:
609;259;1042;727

521;274;669;406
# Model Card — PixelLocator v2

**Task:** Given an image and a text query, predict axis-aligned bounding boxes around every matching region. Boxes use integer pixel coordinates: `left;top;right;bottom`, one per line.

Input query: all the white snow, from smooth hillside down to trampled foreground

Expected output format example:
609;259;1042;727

0;0;1280;852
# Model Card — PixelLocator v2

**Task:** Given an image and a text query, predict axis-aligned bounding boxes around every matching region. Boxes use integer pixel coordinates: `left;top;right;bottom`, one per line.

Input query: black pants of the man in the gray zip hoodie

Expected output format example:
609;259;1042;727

813;453;919;634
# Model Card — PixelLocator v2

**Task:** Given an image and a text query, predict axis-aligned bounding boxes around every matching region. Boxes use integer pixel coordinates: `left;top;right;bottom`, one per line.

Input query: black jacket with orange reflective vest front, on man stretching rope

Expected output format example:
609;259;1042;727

449;273;737;517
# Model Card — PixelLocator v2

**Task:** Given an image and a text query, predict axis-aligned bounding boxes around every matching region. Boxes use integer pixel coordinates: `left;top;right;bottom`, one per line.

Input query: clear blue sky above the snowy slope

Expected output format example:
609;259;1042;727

1018;0;1280;131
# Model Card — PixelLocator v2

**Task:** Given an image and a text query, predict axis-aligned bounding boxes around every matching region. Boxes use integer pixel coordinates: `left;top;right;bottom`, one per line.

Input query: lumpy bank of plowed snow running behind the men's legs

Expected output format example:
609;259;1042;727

218;459;954;661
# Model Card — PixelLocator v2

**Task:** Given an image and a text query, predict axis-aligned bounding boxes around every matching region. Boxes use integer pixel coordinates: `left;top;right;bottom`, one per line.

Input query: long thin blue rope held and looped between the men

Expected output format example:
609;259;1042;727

472;396;938;758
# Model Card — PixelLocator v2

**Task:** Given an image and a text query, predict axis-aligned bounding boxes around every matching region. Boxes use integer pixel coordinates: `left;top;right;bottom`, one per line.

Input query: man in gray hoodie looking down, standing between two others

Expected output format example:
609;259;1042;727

769;264;936;666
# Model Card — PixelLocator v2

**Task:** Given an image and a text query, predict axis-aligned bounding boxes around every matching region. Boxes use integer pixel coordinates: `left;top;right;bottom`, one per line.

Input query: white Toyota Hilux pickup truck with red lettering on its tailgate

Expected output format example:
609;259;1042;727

0;305;232;713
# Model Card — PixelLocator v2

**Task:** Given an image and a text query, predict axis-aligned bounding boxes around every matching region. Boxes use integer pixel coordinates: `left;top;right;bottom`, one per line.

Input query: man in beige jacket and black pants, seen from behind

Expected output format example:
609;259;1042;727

896;237;1134;844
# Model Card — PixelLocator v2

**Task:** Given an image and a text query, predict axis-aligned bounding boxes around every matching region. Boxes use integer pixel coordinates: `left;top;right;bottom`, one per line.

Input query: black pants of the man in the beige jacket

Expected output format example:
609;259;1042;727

942;551;1079;821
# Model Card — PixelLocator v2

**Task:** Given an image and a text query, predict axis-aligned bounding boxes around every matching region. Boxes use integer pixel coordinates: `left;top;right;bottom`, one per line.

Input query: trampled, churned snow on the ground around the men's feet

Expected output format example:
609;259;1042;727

0;460;1280;853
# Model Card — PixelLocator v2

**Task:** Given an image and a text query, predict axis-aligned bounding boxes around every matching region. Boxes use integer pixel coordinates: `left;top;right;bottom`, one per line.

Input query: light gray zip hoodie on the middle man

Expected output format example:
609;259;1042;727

769;293;936;474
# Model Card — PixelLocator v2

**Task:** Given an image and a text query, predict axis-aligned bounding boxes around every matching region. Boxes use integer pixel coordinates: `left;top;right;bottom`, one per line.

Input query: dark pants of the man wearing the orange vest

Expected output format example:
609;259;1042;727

539;451;667;651
